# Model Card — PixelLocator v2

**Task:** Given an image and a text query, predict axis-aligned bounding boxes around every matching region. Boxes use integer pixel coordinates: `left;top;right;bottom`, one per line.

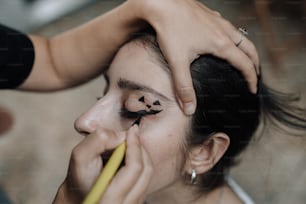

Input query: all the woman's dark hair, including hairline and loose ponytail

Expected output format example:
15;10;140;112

128;33;306;192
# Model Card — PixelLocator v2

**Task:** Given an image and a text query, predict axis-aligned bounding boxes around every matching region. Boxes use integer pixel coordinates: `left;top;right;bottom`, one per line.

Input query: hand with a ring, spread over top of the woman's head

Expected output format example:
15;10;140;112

129;0;259;114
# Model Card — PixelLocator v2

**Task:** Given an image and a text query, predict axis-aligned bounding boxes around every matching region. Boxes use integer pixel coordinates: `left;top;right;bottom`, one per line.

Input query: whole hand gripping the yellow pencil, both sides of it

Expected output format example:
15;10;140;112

54;125;152;204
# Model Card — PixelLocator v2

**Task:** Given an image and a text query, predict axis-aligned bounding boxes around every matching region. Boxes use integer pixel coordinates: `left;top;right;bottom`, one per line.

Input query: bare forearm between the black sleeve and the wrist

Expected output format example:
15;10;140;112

20;3;145;91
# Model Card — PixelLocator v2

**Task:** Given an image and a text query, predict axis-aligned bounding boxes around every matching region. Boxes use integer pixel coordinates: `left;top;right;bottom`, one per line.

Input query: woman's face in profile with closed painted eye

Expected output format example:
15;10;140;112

75;42;188;192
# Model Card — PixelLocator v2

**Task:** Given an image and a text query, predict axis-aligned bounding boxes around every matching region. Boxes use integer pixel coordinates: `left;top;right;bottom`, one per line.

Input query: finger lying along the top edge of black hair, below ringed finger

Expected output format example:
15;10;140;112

213;44;257;94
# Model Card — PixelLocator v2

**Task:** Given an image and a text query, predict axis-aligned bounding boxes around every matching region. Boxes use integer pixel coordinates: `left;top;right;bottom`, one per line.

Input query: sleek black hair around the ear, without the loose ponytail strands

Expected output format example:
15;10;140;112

188;55;260;191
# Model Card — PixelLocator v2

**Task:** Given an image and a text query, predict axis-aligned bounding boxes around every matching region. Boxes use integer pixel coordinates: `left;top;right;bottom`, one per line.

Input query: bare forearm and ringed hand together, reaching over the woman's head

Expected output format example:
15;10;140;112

20;0;259;114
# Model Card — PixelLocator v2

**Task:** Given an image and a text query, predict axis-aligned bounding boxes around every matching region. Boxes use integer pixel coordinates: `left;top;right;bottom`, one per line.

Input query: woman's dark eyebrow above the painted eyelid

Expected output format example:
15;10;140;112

117;78;171;101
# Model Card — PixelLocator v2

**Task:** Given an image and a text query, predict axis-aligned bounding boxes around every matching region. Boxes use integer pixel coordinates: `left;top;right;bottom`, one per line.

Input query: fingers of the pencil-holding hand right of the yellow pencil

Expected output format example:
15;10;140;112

100;125;153;204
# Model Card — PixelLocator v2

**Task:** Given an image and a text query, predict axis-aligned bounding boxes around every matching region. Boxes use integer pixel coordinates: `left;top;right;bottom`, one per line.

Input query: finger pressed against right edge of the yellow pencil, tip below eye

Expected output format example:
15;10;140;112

100;125;143;204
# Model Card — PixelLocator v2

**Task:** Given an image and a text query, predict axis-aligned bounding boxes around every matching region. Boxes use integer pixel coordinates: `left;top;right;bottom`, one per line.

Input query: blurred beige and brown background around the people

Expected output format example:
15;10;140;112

0;0;306;204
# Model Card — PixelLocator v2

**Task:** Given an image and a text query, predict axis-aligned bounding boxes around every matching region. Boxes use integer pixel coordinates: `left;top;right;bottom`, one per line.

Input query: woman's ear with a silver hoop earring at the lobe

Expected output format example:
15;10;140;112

185;132;230;174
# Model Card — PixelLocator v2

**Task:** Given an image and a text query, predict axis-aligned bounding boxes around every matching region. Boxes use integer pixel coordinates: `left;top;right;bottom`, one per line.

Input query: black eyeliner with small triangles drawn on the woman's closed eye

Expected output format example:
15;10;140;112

120;96;162;126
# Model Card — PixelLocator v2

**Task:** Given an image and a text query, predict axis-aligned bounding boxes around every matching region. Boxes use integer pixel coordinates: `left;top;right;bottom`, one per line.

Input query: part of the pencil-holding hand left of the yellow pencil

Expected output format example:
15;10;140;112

54;129;125;203
